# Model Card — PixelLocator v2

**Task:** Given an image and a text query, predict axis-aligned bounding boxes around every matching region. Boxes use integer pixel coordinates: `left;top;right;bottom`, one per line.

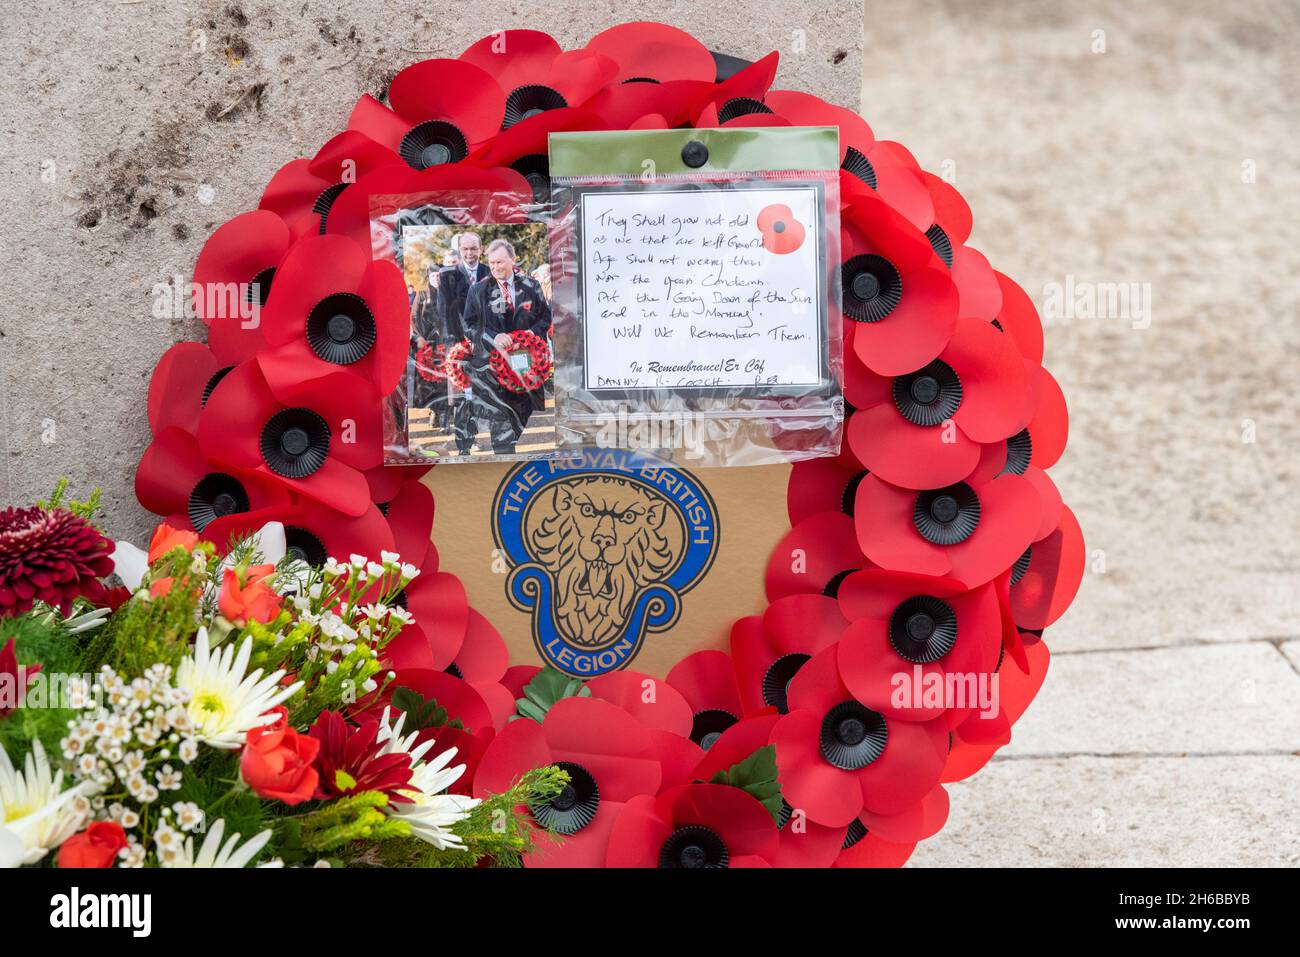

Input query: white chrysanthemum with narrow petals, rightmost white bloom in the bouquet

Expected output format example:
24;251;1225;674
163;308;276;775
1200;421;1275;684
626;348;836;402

376;709;480;850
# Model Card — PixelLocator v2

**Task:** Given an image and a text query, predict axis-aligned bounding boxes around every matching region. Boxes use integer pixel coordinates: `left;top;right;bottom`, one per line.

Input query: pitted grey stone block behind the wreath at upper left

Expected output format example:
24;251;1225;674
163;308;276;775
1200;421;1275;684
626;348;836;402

0;0;863;540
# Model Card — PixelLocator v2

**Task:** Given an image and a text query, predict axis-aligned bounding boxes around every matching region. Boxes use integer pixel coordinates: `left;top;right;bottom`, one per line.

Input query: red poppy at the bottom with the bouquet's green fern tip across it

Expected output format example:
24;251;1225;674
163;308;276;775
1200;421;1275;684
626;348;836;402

475;698;663;867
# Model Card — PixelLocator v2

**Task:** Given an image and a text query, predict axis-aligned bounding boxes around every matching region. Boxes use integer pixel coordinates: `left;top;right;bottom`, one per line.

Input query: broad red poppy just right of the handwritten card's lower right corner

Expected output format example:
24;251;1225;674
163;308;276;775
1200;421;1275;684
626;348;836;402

848;319;1032;489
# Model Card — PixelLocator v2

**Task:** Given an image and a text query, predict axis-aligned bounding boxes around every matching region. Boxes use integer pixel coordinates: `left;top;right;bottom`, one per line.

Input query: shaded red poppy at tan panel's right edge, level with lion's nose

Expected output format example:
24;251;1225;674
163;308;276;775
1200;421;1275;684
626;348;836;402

764;512;867;601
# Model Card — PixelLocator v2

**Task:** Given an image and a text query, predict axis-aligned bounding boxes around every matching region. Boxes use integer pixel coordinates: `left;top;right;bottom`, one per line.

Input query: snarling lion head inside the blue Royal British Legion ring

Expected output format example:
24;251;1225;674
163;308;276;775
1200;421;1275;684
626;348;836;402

525;475;685;648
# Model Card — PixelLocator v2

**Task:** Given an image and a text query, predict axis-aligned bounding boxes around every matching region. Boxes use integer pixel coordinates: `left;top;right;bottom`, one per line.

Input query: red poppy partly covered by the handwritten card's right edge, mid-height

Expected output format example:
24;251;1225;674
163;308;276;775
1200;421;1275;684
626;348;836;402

840;194;958;376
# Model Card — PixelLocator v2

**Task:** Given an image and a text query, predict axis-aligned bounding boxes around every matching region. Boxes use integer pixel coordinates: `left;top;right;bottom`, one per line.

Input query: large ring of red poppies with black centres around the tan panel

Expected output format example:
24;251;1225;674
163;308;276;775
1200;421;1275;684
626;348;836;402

137;23;1084;867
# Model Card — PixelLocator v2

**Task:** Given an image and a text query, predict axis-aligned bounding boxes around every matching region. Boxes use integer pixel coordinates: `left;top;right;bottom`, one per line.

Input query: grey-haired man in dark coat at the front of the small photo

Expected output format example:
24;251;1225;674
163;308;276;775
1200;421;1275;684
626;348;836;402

463;239;551;455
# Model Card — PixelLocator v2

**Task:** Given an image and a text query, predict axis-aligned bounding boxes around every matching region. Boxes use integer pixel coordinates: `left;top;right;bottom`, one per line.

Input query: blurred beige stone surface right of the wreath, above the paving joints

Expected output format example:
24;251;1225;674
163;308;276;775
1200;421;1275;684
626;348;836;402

863;0;1300;649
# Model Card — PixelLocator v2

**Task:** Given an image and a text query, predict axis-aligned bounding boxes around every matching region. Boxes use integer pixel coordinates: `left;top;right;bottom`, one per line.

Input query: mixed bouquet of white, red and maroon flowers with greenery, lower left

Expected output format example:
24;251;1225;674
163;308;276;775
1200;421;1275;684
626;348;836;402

0;484;568;867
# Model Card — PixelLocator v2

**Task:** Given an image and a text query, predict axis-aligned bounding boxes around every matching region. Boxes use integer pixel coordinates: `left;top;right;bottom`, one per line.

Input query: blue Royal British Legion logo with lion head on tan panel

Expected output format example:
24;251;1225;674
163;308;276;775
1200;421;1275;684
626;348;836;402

493;449;718;677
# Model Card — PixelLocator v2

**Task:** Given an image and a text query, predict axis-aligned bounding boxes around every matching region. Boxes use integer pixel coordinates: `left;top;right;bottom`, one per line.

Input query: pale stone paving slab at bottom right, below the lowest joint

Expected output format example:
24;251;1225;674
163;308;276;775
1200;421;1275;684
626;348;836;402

909;757;1300;867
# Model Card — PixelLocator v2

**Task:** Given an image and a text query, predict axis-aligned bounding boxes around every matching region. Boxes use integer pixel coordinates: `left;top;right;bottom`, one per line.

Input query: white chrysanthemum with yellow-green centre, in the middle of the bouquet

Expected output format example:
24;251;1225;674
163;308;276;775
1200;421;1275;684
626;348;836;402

176;628;303;750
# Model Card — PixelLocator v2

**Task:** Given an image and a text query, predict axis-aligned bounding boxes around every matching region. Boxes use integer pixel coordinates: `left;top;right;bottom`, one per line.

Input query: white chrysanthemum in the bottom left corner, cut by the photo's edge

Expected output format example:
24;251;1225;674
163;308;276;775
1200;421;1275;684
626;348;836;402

0;740;96;863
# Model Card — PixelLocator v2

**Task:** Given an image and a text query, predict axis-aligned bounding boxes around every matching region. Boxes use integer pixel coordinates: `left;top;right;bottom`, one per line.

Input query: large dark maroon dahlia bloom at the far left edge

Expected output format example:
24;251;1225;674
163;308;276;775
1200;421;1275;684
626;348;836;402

0;507;113;618
